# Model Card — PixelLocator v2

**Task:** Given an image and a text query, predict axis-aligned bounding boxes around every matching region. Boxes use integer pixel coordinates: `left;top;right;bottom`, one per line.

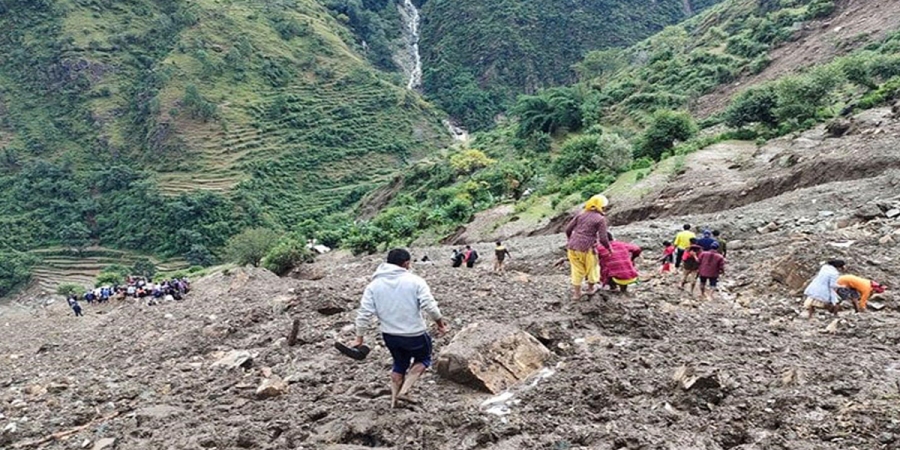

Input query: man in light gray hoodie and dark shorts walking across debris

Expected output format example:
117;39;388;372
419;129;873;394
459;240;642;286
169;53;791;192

355;249;447;408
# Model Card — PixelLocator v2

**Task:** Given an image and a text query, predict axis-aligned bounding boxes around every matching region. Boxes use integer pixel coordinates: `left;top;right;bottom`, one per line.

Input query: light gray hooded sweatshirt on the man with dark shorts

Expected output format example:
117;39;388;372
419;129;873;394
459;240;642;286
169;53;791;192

356;263;441;336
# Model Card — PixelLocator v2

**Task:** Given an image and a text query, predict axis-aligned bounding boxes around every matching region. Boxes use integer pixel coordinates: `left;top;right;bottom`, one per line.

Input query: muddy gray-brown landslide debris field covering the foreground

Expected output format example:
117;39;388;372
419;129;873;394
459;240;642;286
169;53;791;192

0;121;900;450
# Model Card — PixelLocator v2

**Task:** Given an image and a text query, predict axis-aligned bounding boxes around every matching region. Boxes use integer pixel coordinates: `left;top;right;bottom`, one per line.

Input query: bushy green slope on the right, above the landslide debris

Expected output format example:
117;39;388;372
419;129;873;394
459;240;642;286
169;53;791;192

354;0;900;251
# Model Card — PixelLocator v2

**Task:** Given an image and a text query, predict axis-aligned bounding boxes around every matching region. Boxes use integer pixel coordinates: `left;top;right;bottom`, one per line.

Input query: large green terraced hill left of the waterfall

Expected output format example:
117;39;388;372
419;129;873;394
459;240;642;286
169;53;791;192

0;0;447;292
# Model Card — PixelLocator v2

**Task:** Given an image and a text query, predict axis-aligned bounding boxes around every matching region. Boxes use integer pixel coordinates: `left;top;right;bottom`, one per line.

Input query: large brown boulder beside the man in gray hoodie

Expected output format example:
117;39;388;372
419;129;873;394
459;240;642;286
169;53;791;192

435;322;551;394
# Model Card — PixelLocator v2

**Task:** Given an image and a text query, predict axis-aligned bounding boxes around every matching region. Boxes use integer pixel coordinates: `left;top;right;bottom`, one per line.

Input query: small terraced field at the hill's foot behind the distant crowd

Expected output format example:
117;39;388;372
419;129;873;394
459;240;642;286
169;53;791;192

32;247;188;292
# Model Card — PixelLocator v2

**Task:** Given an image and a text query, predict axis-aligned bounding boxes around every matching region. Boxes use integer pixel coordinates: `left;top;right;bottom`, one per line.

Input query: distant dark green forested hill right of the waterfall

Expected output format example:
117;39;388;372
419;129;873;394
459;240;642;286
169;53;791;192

422;0;719;129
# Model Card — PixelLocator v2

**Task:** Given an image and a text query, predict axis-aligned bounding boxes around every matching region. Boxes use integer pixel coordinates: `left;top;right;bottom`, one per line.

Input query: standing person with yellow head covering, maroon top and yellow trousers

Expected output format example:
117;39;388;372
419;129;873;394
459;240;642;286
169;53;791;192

566;195;612;300
